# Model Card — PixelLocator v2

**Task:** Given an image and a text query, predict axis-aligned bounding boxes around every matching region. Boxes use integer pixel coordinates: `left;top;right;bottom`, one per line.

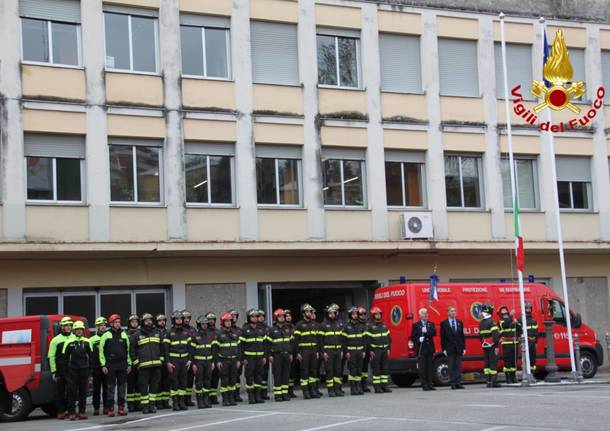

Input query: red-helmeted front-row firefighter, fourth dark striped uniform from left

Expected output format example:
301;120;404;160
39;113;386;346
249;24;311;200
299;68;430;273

213;313;241;407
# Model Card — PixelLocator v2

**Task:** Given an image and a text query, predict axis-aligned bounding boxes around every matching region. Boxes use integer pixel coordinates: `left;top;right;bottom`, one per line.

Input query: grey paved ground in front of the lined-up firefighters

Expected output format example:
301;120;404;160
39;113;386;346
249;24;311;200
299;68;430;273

1;383;610;431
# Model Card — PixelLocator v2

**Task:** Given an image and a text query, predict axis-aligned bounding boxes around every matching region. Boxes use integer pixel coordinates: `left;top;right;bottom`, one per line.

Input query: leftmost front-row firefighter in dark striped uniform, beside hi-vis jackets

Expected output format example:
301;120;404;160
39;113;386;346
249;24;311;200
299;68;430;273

130;313;164;414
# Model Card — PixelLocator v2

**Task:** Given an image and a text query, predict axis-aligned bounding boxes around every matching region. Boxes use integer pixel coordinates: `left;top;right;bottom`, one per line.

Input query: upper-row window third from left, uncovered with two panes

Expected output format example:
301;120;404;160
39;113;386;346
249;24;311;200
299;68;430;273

180;14;230;79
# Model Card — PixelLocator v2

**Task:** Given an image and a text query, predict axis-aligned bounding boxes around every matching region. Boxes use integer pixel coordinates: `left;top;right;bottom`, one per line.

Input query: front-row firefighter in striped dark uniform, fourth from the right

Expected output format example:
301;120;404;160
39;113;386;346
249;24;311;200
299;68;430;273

293;304;320;400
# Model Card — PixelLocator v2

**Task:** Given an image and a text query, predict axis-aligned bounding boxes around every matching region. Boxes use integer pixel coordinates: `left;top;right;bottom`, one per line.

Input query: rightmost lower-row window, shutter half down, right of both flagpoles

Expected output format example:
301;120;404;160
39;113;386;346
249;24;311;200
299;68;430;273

556;156;593;210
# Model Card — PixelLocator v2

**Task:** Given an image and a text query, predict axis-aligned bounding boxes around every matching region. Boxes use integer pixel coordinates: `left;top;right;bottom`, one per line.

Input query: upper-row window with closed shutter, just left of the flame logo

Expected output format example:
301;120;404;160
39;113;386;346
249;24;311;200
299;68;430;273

494;42;534;100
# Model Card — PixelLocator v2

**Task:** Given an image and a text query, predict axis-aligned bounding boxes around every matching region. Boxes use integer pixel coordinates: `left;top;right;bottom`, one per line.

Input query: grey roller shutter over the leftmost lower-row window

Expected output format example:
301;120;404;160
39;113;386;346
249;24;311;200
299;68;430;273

24;133;85;159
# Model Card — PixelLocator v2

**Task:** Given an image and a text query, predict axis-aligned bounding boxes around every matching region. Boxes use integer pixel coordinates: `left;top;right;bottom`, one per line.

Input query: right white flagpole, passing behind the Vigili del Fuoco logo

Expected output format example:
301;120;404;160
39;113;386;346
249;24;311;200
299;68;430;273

539;17;576;377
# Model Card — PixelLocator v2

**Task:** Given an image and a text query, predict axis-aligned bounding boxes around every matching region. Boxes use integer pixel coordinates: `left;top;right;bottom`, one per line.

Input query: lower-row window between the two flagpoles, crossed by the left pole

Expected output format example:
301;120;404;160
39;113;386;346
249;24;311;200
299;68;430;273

501;158;538;210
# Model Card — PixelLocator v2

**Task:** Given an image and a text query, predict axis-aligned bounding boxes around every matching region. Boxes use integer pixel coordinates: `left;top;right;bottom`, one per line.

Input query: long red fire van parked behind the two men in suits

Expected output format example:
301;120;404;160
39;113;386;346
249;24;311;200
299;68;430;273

373;283;604;386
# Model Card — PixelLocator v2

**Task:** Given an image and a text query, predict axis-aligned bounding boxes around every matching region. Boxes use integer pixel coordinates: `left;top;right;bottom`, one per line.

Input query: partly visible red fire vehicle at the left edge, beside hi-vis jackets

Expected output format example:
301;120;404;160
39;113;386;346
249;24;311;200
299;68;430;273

0;315;89;422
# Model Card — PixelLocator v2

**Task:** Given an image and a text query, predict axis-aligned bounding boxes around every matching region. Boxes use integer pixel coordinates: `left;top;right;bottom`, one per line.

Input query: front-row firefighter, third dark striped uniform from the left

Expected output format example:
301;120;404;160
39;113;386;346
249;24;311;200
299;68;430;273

191;316;216;409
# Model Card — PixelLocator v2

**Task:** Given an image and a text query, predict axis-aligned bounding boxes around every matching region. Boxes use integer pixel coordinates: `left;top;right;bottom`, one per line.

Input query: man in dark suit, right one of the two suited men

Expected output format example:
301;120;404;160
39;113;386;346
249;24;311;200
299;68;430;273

441;306;466;389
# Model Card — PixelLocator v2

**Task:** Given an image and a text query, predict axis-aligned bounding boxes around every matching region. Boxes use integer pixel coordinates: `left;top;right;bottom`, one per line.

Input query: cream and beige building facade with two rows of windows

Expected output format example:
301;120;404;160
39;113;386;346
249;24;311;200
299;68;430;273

0;0;610;348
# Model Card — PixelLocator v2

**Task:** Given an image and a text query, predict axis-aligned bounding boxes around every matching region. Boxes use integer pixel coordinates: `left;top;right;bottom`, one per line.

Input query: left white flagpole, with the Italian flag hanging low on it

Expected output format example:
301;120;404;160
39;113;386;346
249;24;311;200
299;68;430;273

499;13;532;382
